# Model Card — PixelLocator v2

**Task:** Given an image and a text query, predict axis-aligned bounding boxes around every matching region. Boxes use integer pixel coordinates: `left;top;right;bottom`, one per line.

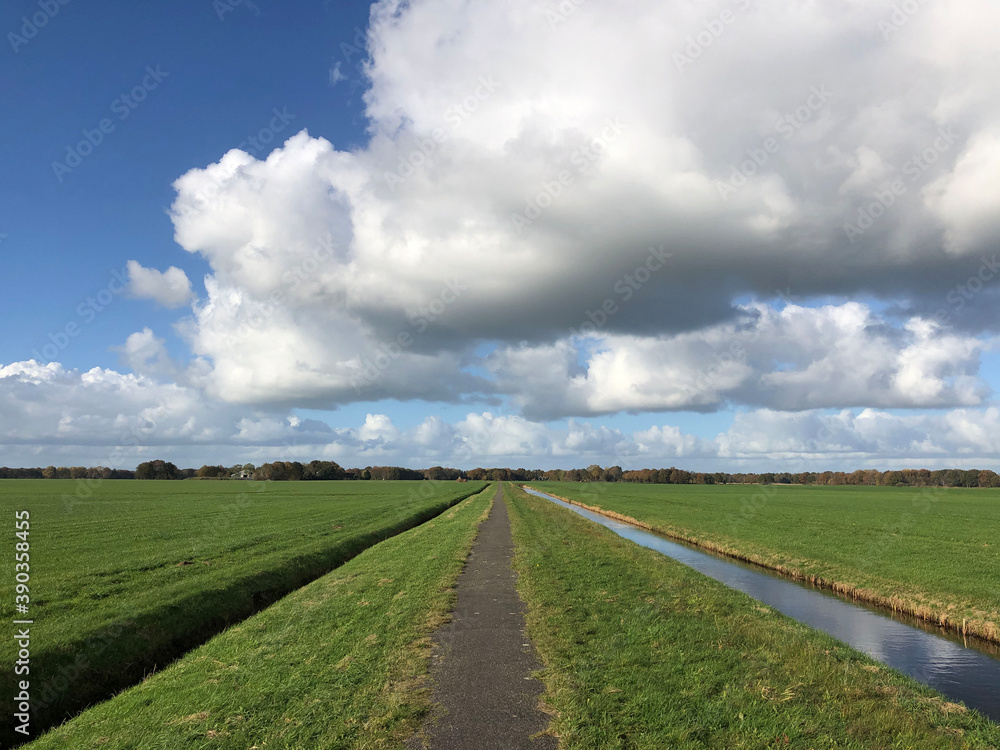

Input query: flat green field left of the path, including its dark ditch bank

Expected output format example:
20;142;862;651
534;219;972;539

0;480;484;738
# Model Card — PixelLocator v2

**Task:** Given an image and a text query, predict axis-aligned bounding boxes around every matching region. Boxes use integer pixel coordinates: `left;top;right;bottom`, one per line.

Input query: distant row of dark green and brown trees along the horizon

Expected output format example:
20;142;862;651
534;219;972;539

0;459;1000;487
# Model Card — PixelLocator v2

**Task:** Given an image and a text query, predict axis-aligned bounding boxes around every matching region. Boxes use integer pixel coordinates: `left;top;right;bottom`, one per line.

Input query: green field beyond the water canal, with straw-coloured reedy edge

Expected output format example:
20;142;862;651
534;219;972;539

530;482;1000;640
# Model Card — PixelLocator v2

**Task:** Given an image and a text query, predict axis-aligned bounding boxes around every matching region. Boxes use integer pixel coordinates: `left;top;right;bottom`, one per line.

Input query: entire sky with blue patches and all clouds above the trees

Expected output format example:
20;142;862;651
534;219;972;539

0;0;1000;471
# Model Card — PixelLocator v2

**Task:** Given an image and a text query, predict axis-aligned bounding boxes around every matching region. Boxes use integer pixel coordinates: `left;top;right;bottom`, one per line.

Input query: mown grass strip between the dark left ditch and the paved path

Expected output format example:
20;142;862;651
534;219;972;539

17;486;495;750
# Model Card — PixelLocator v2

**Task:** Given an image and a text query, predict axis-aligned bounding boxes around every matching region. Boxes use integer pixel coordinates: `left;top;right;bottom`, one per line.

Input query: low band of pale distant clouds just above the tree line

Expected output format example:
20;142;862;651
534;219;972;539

0;360;1000;470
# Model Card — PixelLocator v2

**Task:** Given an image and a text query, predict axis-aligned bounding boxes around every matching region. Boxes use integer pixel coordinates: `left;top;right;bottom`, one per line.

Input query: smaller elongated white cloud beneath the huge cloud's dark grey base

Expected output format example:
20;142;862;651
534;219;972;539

489;302;991;419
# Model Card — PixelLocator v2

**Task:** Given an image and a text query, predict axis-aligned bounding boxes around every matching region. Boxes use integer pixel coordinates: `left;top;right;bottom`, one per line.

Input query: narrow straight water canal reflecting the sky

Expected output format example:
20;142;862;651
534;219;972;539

524;487;1000;722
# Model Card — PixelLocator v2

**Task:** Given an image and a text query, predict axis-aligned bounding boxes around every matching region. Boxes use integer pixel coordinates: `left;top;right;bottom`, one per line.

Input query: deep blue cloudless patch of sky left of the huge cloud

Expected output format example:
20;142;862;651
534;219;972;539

0;1;369;368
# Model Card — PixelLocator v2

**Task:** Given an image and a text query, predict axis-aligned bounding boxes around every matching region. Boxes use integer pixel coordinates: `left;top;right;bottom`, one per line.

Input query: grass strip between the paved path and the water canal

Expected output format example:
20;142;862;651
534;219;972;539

505;487;1000;750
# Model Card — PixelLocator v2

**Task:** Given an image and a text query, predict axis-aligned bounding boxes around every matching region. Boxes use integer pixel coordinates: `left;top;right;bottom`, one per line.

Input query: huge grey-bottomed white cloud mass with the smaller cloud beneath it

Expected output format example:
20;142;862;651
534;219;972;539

148;0;1000;416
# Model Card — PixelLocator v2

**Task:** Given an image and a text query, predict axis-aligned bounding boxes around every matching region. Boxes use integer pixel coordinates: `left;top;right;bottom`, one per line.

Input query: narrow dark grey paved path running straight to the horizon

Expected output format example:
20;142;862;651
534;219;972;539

408;488;557;750
